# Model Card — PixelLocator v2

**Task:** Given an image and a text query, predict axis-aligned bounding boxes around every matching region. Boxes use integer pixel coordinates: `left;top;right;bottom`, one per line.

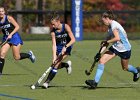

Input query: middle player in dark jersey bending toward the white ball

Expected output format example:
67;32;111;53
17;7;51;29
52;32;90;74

43;14;75;88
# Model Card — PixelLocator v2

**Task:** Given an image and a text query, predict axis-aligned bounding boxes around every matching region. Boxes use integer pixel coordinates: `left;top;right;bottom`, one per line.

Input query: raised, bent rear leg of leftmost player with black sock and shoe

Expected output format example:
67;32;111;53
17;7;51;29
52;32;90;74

12;44;35;63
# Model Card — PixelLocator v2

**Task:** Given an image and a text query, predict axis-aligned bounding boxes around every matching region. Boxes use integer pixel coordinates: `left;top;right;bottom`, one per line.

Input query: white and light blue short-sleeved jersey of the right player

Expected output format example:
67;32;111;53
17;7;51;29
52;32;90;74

108;20;131;52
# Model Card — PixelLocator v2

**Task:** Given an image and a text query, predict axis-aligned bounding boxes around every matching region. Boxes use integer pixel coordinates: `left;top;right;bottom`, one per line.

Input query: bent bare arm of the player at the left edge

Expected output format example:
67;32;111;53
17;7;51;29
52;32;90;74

8;16;19;36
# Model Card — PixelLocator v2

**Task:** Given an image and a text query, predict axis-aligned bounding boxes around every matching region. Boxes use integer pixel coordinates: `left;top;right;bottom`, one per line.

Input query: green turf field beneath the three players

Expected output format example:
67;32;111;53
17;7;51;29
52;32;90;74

0;41;140;100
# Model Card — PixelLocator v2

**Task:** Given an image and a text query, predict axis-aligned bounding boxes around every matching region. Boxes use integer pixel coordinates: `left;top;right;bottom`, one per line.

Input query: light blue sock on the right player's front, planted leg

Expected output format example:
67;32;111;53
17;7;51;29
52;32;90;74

94;64;104;83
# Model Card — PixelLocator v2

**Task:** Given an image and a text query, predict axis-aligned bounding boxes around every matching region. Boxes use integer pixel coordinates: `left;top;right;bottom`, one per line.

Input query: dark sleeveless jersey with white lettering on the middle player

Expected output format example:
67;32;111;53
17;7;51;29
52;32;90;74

53;24;70;46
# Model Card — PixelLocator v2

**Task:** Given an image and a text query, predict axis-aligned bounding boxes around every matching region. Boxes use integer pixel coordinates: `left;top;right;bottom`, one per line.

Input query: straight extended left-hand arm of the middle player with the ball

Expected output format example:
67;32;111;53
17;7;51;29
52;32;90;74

51;32;56;63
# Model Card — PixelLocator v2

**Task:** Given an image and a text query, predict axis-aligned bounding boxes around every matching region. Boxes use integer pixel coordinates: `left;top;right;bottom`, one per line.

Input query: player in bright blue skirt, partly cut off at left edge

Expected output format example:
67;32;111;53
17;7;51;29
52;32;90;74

0;7;35;75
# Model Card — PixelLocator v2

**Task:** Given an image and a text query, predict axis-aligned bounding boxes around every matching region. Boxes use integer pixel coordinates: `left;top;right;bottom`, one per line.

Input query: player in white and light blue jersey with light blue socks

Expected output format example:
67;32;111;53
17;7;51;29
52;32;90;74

85;10;140;89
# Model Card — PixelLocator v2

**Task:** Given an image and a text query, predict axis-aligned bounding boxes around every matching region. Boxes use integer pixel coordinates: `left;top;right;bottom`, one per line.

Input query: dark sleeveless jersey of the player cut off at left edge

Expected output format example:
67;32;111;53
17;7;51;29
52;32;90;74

0;15;15;35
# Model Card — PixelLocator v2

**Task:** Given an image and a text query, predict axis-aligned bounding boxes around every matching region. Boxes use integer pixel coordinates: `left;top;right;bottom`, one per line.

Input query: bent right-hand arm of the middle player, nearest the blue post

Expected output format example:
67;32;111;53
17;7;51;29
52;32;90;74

65;24;75;47
